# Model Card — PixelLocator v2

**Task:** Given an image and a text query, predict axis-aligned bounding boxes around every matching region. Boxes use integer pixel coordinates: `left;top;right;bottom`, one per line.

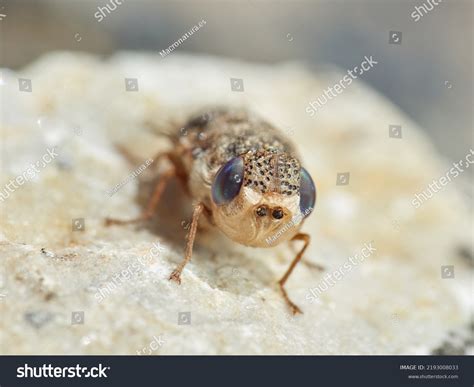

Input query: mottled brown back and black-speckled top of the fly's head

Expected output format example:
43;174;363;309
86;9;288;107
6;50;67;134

176;109;300;195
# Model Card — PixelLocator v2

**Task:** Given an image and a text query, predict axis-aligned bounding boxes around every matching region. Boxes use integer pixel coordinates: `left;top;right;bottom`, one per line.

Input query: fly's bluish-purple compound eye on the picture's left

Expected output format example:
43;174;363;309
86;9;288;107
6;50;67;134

212;157;244;205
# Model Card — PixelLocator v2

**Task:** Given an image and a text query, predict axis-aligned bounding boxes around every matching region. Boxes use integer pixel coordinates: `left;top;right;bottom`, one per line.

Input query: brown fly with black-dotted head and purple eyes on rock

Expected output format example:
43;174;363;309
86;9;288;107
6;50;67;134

106;109;316;314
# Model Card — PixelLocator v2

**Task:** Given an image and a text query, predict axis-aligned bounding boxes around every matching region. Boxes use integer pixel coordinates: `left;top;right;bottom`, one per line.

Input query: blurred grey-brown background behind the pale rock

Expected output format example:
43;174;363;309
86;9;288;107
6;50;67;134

0;0;473;161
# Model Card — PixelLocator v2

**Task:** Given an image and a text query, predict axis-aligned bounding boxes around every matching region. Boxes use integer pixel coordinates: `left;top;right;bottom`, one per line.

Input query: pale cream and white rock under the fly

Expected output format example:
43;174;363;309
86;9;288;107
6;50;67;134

0;53;472;354
